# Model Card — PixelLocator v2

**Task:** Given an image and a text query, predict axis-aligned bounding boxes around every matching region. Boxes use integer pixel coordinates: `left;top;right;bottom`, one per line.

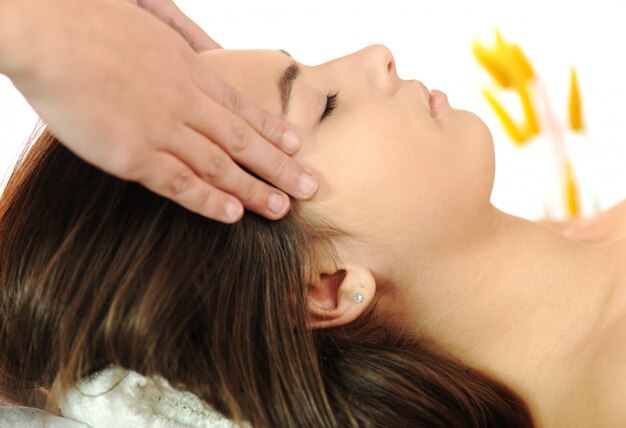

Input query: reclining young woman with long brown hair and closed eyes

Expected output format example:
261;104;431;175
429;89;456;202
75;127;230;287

0;46;626;427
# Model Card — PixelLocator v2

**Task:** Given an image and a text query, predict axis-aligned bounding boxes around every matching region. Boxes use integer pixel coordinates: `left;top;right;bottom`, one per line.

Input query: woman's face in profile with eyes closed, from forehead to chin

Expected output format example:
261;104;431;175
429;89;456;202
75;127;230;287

203;45;494;274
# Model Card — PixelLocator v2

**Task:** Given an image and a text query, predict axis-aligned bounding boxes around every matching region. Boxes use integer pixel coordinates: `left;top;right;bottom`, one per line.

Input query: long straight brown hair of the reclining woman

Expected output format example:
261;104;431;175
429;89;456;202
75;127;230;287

0;131;532;427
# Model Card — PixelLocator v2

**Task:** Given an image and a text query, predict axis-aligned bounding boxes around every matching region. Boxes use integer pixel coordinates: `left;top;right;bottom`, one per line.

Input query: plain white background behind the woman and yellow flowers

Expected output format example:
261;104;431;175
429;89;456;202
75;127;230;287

0;0;626;218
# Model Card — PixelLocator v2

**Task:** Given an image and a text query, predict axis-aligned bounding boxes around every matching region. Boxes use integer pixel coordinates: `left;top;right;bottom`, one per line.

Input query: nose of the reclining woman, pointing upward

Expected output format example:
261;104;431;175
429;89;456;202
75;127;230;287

354;45;400;94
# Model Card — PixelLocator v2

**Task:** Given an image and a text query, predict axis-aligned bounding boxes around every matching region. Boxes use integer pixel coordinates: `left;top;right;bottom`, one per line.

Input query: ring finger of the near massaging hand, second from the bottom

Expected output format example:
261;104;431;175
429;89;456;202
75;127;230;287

170;128;289;220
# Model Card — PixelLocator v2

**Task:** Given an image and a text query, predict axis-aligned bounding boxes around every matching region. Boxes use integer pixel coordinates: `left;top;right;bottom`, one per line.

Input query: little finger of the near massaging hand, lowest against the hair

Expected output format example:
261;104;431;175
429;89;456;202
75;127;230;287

132;151;243;223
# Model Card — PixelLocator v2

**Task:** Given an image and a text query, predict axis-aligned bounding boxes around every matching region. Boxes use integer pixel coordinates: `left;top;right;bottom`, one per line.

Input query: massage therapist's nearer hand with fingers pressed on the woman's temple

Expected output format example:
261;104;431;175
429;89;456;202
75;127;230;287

0;0;317;222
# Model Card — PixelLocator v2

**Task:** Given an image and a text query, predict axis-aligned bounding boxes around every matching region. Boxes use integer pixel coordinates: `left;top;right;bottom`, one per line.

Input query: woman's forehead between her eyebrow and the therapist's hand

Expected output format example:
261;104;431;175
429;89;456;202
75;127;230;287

200;49;293;115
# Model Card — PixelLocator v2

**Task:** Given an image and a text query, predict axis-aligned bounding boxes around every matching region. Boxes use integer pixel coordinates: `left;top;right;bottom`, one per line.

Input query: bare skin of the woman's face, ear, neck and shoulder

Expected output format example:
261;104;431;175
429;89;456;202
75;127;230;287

202;46;626;427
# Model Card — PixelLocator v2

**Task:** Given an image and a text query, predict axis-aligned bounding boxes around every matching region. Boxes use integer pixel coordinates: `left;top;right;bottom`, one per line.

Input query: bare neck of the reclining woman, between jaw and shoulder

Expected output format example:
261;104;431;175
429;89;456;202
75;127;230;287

381;205;625;426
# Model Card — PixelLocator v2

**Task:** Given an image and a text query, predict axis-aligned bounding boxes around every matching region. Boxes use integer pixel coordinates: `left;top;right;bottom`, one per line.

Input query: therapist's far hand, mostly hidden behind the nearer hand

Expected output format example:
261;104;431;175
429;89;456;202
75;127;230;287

121;0;221;52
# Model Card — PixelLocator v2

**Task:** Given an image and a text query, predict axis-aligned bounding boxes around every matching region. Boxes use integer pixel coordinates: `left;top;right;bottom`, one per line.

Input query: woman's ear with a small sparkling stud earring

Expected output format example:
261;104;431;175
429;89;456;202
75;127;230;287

307;265;376;328
